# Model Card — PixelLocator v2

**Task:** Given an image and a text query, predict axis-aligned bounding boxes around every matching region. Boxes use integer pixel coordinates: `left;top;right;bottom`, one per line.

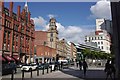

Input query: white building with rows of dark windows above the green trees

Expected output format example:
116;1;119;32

85;30;111;53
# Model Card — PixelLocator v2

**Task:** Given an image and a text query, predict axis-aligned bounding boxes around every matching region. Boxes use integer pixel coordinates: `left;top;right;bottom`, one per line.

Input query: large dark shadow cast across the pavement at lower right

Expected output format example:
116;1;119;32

61;68;111;80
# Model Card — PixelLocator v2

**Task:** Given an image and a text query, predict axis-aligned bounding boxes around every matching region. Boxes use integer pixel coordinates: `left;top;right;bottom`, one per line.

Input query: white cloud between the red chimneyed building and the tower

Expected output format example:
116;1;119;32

32;16;47;30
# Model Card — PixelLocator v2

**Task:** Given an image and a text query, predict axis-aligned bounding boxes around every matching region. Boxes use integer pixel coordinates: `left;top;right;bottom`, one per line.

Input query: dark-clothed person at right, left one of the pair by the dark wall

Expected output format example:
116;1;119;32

104;60;112;80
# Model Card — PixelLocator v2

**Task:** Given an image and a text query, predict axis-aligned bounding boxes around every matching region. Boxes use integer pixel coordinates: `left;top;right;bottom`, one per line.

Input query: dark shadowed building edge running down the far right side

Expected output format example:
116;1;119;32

111;1;120;80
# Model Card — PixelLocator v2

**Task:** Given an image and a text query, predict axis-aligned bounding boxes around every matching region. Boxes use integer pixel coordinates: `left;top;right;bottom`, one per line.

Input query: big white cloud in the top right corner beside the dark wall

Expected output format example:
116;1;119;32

89;0;111;19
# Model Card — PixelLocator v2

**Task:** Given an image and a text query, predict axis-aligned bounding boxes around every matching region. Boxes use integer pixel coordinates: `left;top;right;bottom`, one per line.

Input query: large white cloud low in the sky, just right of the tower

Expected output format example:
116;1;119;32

58;26;93;43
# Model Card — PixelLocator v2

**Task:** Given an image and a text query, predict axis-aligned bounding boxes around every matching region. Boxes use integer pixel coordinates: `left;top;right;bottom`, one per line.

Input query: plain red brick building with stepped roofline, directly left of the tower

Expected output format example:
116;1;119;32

35;31;56;63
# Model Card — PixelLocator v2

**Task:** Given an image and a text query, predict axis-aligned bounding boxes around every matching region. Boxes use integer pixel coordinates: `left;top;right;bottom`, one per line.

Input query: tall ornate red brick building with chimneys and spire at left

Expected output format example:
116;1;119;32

0;2;35;62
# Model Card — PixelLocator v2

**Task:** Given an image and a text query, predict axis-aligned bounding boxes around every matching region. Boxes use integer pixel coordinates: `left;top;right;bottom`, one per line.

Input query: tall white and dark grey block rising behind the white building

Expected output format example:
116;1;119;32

96;19;113;35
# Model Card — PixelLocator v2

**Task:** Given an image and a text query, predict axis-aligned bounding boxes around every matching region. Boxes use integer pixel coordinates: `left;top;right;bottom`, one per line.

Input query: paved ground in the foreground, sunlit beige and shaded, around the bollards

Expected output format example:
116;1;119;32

3;67;105;80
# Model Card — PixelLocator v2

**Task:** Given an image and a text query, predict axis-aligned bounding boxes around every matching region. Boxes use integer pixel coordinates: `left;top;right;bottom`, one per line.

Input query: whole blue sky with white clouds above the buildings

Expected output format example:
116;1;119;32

5;0;111;43
